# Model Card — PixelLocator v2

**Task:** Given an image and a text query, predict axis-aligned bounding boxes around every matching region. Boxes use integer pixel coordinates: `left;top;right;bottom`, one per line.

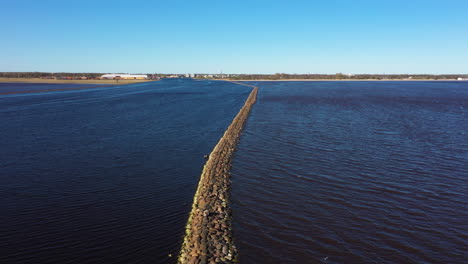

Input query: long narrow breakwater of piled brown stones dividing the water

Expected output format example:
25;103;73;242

178;82;258;264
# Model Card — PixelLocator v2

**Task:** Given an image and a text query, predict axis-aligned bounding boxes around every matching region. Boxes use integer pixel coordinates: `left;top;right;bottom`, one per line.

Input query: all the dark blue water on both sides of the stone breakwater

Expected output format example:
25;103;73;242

0;80;468;263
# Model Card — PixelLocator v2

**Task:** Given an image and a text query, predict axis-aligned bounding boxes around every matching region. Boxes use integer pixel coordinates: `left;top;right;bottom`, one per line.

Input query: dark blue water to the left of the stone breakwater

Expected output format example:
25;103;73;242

0;80;251;264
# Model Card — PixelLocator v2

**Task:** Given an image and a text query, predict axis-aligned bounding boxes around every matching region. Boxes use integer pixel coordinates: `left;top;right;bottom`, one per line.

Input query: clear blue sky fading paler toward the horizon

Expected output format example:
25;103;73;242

0;0;468;74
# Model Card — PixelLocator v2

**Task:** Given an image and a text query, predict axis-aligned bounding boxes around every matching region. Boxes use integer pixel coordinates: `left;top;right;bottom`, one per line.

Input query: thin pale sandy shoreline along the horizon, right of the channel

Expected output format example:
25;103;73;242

210;78;459;82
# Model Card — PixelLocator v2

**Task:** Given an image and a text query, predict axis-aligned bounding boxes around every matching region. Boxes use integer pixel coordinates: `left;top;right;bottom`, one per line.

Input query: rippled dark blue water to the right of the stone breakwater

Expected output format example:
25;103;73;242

232;82;468;264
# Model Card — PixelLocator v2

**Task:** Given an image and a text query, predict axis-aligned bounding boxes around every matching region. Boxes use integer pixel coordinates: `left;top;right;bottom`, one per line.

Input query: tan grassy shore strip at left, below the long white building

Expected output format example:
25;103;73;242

0;77;154;85
